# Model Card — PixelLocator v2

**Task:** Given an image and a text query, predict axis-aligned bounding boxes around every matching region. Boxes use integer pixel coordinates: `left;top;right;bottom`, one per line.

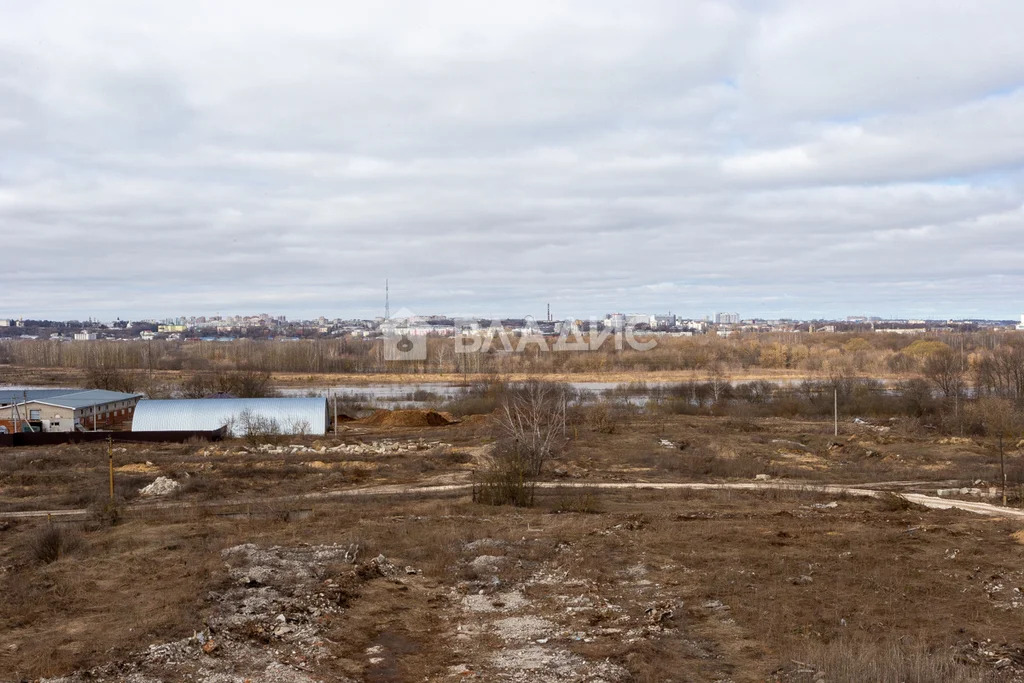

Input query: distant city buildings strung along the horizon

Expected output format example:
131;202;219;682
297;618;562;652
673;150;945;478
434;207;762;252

6;311;1024;341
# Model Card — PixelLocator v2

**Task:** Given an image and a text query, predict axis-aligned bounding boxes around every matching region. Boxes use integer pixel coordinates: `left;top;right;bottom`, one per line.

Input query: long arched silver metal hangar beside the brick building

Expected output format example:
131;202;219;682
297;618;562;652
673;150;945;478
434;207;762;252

132;397;330;436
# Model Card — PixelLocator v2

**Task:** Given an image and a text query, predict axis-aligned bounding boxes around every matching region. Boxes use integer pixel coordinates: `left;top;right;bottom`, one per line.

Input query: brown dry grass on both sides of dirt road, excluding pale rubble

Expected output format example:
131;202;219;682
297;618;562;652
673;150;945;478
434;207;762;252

0;409;1024;681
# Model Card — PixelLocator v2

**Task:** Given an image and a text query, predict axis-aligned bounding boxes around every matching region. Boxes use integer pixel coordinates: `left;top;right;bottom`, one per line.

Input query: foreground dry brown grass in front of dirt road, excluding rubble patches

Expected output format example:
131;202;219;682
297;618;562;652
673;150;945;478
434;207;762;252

0;490;1024;681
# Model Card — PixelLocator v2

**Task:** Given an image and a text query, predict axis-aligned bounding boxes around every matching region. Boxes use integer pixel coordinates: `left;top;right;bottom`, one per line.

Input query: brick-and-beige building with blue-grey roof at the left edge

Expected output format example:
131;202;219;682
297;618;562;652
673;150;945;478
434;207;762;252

0;389;142;433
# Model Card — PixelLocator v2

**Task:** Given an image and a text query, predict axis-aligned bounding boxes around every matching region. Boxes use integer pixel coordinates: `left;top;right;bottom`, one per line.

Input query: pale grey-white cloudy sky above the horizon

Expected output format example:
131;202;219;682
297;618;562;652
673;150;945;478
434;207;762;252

0;0;1024;318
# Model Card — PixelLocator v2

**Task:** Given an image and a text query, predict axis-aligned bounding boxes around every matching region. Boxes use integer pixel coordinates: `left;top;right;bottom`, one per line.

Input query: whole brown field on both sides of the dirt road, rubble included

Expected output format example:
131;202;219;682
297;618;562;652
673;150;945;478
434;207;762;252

0;416;1024;683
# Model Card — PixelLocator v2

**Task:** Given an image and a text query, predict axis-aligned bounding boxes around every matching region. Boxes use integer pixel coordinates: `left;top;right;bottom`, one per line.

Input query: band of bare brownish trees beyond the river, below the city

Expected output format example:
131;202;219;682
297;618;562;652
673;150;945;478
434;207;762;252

0;332;1024;398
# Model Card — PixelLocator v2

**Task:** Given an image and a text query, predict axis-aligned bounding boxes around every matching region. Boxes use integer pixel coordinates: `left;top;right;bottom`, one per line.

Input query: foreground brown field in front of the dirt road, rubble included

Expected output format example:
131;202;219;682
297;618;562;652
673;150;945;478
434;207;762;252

0;492;1024;681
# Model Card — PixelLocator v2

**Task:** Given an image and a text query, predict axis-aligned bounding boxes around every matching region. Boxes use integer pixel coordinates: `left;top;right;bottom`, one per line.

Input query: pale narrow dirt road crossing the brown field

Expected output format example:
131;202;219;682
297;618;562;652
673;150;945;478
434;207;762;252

0;481;1024;519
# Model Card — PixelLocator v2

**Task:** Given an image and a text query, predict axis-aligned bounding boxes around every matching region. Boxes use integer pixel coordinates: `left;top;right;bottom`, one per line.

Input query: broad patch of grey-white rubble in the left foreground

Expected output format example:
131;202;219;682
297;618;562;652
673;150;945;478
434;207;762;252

40;543;407;683
